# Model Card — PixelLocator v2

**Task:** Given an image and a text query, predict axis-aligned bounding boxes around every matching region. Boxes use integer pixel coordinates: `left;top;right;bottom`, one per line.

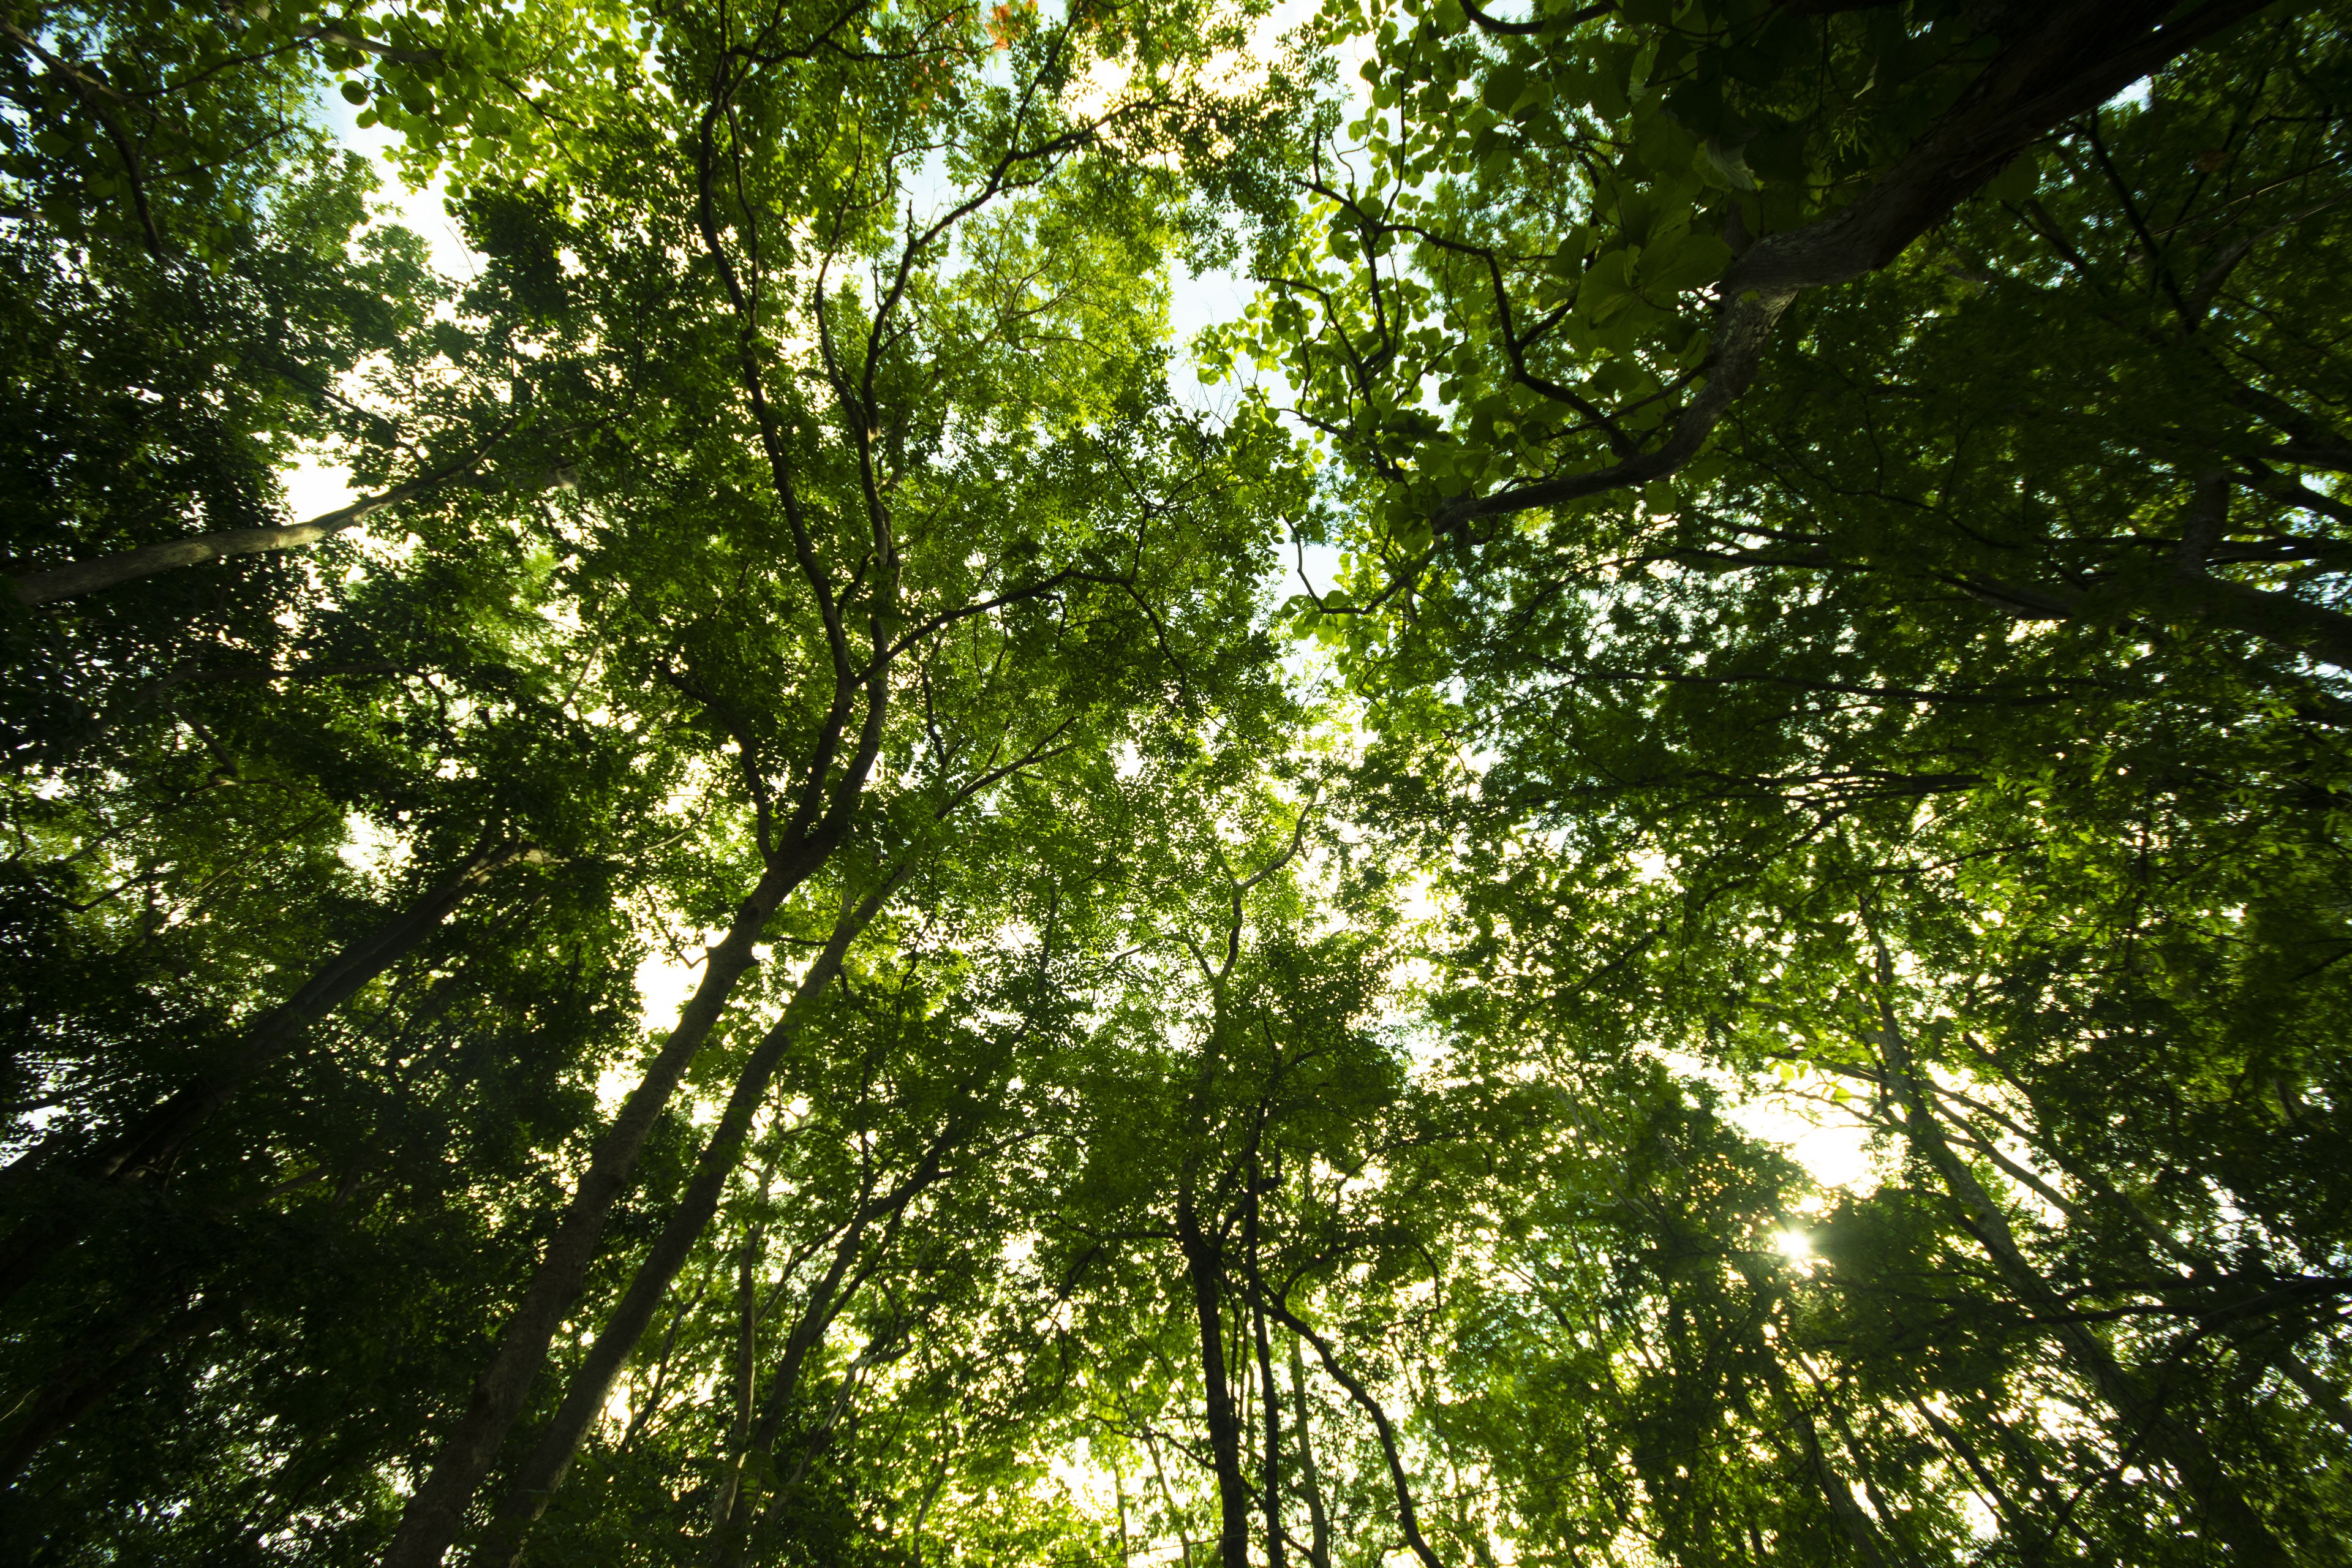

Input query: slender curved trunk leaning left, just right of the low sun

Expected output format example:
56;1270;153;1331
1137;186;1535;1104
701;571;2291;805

1879;1001;2291;1568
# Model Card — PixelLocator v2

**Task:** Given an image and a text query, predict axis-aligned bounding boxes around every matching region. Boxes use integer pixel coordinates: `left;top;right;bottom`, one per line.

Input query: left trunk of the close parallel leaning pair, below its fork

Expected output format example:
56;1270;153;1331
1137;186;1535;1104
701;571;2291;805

383;851;826;1568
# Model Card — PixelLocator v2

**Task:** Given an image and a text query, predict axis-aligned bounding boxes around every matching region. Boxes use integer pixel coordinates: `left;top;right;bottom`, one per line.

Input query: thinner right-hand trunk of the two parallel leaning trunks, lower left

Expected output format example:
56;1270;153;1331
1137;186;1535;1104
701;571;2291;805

478;863;913;1563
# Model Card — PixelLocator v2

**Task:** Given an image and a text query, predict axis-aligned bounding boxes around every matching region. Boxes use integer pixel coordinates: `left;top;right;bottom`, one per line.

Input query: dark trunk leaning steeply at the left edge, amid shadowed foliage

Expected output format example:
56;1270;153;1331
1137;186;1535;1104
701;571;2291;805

0;846;524;1300
